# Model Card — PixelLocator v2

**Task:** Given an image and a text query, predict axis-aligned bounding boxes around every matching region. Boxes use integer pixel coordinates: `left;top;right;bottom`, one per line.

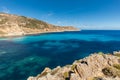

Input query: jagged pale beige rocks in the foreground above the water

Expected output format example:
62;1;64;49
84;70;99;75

27;52;120;80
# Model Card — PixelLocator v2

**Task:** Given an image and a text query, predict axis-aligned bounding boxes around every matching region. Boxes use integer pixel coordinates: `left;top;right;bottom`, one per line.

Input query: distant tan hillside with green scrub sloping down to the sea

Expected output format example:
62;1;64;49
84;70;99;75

0;13;78;37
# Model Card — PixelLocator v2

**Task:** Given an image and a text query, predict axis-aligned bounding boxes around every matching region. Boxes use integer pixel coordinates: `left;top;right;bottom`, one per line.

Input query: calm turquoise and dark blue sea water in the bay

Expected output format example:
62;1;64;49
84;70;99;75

0;30;120;80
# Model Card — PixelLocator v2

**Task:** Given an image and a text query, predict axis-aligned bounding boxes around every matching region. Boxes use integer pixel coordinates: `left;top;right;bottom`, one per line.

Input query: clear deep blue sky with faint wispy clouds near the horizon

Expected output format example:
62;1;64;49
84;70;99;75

0;0;120;30
